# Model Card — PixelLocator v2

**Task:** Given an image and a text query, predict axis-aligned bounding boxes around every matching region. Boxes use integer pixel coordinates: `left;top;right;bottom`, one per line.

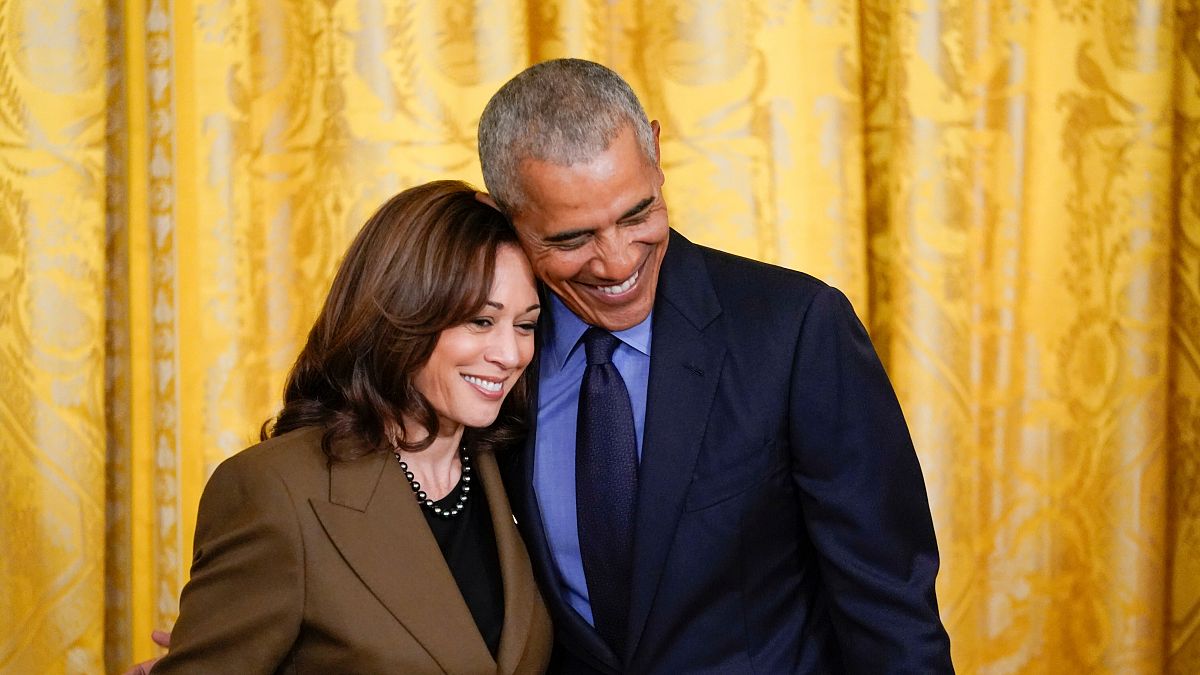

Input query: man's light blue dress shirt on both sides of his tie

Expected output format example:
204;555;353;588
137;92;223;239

533;293;654;626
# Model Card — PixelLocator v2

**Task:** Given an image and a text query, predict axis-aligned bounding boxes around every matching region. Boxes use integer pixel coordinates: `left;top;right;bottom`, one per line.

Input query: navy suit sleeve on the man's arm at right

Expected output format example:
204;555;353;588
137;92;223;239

790;282;953;673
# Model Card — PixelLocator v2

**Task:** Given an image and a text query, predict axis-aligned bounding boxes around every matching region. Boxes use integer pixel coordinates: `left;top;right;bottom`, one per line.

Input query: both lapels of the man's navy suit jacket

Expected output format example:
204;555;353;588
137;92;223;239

514;231;725;673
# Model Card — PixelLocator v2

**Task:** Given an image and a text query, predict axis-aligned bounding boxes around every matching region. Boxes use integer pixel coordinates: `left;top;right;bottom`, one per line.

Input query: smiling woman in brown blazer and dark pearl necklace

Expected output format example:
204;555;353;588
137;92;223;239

154;181;551;675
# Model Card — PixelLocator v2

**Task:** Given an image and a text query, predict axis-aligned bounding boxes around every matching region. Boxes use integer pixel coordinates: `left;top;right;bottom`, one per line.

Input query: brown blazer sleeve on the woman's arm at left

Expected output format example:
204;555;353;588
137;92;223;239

154;455;304;675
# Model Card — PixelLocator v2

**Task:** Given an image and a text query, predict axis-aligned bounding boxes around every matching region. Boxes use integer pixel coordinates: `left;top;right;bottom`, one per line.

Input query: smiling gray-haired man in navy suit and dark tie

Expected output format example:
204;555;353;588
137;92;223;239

479;59;953;673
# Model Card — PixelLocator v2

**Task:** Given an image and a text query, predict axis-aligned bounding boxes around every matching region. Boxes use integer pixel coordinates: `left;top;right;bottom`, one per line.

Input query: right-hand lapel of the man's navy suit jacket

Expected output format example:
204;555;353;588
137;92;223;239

625;231;725;663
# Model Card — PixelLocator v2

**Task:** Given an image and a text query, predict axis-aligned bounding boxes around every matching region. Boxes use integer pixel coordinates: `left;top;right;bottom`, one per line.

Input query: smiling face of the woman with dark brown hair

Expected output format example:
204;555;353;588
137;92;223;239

414;245;540;435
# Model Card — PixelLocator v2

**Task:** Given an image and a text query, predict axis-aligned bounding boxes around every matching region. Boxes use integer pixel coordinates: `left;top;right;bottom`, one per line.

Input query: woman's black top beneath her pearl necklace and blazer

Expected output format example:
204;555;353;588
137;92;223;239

421;461;504;658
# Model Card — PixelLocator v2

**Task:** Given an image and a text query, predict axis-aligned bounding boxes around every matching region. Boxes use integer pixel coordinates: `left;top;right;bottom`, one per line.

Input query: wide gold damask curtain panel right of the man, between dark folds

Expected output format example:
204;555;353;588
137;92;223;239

864;1;1195;673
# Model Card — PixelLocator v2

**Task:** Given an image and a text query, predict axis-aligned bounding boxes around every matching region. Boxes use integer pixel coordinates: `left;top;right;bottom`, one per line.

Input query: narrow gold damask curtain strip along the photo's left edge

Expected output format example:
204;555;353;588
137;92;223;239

0;0;106;673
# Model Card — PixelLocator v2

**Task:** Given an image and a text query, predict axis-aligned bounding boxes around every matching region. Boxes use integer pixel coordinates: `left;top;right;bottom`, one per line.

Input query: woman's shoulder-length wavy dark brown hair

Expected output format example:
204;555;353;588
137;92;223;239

262;180;526;460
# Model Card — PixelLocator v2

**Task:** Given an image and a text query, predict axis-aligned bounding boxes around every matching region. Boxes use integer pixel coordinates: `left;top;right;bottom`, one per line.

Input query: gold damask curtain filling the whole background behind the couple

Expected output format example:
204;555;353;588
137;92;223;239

0;0;1200;674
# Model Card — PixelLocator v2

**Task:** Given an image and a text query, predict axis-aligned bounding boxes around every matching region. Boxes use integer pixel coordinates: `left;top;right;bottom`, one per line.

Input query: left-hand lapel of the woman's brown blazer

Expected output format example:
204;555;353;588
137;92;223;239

310;444;498;673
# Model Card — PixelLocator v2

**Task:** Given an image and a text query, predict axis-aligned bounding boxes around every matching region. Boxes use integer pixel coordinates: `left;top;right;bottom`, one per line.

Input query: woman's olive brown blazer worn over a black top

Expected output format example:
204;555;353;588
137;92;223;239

154;428;551;675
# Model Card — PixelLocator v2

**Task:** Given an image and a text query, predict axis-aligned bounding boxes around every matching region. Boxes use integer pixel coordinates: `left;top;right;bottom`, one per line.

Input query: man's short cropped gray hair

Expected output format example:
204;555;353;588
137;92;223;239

479;59;658;214
